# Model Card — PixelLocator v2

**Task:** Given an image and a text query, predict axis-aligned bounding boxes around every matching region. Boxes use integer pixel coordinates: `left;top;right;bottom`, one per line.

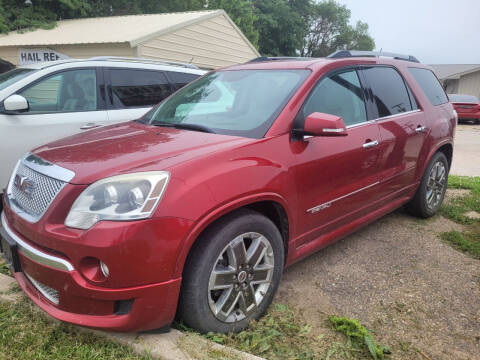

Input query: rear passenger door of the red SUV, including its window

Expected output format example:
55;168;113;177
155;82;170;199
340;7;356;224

361;65;428;196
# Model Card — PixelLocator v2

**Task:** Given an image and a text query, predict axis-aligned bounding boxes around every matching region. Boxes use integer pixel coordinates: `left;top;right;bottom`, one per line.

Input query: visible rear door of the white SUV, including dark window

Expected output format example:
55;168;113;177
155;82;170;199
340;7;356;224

106;68;173;122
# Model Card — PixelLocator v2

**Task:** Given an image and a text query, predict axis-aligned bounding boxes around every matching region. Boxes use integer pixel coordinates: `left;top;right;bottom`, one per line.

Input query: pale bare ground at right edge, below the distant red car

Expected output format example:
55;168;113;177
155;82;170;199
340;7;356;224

451;123;480;176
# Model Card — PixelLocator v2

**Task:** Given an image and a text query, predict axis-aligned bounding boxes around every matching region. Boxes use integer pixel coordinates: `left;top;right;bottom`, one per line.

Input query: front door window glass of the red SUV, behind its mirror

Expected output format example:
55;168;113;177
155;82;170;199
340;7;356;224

303;70;367;126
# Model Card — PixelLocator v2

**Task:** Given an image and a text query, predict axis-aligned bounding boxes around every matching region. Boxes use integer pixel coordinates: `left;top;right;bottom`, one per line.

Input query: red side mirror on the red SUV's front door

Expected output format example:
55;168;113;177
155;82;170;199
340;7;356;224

303;112;347;136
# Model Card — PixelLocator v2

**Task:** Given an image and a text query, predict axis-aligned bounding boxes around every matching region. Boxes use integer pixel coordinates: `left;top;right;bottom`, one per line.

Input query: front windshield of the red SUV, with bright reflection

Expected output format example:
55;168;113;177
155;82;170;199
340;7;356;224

141;70;309;138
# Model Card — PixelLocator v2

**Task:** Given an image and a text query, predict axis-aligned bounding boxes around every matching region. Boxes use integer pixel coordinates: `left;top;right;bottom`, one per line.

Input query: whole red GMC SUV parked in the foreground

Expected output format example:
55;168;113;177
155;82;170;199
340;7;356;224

1;51;457;332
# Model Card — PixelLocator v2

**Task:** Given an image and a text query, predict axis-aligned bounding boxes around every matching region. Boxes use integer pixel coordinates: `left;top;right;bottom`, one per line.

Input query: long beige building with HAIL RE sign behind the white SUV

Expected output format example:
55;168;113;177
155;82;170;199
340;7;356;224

0;10;259;69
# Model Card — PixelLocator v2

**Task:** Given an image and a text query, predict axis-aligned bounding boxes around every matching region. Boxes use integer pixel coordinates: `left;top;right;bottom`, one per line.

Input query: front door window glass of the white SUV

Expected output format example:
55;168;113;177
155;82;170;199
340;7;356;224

19;69;97;113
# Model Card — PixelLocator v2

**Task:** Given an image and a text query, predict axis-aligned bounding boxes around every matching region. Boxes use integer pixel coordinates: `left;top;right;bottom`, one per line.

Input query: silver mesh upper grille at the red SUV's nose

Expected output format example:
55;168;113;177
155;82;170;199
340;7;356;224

9;163;66;220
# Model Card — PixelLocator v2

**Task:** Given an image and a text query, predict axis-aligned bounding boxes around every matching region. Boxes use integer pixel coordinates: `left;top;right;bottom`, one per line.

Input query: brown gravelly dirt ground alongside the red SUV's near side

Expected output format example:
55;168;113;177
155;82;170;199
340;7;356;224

275;195;480;360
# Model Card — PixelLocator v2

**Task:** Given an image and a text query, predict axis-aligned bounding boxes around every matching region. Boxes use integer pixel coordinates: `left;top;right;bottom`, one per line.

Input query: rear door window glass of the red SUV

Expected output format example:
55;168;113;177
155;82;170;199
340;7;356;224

362;66;412;118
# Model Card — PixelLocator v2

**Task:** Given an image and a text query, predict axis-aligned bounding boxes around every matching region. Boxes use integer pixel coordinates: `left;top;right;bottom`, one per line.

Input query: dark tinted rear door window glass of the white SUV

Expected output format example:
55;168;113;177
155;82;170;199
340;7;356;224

109;69;172;109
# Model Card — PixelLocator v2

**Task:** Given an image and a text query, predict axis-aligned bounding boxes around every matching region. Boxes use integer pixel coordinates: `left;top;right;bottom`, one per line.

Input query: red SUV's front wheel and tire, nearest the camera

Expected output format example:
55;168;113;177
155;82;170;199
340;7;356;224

179;209;284;333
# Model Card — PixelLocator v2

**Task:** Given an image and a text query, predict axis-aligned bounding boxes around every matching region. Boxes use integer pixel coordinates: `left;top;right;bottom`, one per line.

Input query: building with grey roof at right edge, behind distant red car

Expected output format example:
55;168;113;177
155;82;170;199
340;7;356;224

431;64;480;98
